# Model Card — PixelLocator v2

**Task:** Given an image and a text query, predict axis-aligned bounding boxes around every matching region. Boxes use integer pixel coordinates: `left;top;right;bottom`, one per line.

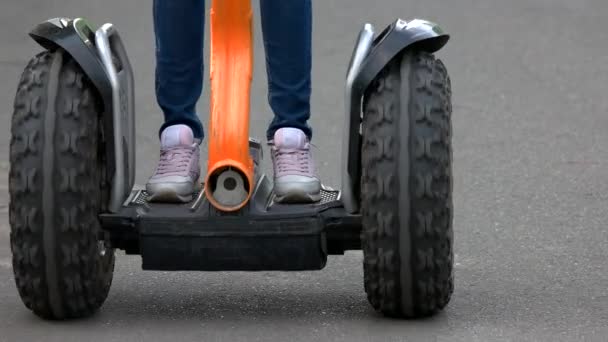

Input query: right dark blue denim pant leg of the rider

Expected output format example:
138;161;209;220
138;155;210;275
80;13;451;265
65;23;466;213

260;0;312;140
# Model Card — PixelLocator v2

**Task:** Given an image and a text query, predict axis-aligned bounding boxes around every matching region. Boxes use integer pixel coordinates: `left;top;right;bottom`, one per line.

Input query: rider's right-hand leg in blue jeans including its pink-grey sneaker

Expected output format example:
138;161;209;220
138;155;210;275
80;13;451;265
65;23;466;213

260;0;321;202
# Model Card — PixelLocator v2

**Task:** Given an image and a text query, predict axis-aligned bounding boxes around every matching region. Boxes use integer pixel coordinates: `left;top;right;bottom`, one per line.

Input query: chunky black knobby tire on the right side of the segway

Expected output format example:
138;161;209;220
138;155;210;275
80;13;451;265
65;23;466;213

361;51;454;318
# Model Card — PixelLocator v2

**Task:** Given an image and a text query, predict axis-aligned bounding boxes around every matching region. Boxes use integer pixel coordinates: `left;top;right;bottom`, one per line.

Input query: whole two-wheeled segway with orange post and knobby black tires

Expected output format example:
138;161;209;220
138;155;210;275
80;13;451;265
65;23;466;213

10;0;453;319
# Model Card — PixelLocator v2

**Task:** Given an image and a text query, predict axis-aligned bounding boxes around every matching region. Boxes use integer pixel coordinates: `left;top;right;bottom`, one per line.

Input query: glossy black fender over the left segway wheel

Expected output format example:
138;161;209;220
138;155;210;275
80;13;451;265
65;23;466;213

29;18;116;190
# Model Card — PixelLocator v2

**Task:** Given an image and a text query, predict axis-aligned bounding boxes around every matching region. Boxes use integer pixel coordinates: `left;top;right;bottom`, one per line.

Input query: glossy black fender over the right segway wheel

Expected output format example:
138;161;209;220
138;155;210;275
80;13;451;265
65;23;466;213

342;19;449;213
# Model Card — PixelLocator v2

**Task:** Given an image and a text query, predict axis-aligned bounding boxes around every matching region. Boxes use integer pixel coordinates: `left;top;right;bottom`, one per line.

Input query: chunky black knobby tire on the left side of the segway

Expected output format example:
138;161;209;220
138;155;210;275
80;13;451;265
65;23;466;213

9;50;114;319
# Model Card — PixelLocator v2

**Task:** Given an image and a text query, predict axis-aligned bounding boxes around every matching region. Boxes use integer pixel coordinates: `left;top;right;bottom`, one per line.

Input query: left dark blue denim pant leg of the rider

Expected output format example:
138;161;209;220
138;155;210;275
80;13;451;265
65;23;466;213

153;0;205;139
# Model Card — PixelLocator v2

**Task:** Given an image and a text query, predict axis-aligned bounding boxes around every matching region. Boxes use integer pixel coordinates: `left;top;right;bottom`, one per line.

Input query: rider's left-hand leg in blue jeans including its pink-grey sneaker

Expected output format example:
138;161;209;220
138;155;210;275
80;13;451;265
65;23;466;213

146;0;205;202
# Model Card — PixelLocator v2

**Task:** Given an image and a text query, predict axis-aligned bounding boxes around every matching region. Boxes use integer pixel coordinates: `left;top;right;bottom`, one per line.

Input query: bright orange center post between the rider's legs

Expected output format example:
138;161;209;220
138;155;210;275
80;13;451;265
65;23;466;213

205;0;253;211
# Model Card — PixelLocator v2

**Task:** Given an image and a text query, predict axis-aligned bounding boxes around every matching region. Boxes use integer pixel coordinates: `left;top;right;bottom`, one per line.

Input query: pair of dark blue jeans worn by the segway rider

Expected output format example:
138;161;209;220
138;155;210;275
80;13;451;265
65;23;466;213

153;0;312;140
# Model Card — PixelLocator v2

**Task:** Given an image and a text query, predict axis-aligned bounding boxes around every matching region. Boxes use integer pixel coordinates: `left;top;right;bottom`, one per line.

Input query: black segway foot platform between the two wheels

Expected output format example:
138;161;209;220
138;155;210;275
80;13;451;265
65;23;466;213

101;142;361;271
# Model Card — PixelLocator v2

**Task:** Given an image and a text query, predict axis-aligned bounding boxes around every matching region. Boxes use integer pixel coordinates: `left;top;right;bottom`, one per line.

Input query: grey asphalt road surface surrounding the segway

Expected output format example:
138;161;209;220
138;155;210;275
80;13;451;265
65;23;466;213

0;0;608;342
